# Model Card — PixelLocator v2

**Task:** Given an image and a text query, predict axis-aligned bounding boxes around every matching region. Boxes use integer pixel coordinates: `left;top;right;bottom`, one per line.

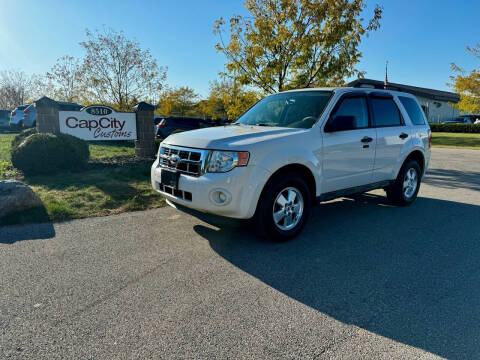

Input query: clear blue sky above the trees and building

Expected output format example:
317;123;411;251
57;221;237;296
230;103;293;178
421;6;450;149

0;0;480;95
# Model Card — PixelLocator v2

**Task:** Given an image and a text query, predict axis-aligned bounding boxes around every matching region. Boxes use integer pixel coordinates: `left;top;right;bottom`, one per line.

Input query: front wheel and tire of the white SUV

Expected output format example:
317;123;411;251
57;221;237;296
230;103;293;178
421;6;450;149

256;173;311;241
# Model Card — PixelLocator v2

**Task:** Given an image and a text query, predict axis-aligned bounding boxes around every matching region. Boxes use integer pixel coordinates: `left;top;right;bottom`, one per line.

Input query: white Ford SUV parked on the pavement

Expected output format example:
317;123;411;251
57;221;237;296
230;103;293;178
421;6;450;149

151;88;431;240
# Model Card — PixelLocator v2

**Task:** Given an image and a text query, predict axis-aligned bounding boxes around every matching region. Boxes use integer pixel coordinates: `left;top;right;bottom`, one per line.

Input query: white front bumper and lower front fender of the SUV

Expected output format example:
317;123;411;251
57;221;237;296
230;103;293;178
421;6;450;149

151;159;270;219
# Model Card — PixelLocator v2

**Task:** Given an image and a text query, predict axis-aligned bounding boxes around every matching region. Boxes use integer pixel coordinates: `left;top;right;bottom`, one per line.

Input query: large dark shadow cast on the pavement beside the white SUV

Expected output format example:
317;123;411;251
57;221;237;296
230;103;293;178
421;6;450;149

195;195;480;359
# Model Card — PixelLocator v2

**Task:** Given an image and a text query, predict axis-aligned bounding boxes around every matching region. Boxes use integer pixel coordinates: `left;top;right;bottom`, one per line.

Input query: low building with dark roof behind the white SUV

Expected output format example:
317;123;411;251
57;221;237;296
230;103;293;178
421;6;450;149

348;79;460;123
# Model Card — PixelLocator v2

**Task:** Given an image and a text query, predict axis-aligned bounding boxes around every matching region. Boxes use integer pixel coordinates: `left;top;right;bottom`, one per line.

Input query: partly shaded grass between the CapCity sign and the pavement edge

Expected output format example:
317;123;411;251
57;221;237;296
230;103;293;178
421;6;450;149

0;161;165;224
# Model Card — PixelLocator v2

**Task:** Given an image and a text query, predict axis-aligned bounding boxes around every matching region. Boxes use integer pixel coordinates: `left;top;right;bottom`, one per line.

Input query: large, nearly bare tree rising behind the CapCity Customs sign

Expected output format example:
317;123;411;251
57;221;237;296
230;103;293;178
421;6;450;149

80;29;167;110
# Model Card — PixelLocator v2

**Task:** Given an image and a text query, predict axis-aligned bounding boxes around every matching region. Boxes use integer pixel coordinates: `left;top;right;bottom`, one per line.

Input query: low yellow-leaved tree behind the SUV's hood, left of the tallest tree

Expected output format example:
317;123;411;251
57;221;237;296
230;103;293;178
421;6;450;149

199;79;260;120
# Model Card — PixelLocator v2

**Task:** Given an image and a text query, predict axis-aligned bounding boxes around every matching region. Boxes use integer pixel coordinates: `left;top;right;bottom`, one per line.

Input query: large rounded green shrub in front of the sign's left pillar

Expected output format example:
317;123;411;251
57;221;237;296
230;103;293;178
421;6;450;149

11;133;90;175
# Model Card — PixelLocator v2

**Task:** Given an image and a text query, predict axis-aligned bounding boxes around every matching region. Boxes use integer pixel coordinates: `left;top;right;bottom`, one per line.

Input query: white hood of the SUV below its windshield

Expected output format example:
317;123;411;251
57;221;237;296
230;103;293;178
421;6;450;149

163;125;307;150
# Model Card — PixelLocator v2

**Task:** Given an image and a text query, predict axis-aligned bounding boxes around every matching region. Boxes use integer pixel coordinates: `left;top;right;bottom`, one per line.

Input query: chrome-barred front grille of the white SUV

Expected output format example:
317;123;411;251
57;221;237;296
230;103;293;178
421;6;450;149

160;145;207;176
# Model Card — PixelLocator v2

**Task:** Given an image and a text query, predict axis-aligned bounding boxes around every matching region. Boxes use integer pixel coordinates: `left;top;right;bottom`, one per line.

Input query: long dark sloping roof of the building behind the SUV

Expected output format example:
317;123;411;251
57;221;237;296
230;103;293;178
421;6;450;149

348;79;460;104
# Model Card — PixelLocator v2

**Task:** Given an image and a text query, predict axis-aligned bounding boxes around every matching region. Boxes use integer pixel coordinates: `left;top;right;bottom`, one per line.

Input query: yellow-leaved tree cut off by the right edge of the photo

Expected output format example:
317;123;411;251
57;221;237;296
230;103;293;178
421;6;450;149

449;44;480;114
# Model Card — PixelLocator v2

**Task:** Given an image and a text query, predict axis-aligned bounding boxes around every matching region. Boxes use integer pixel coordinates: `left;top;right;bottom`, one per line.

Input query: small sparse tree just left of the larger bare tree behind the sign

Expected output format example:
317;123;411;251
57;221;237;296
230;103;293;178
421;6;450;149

46;55;84;102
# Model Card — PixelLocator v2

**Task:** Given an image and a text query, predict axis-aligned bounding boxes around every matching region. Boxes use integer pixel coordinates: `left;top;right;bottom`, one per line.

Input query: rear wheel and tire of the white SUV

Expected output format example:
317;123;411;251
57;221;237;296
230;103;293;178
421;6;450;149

385;160;421;206
